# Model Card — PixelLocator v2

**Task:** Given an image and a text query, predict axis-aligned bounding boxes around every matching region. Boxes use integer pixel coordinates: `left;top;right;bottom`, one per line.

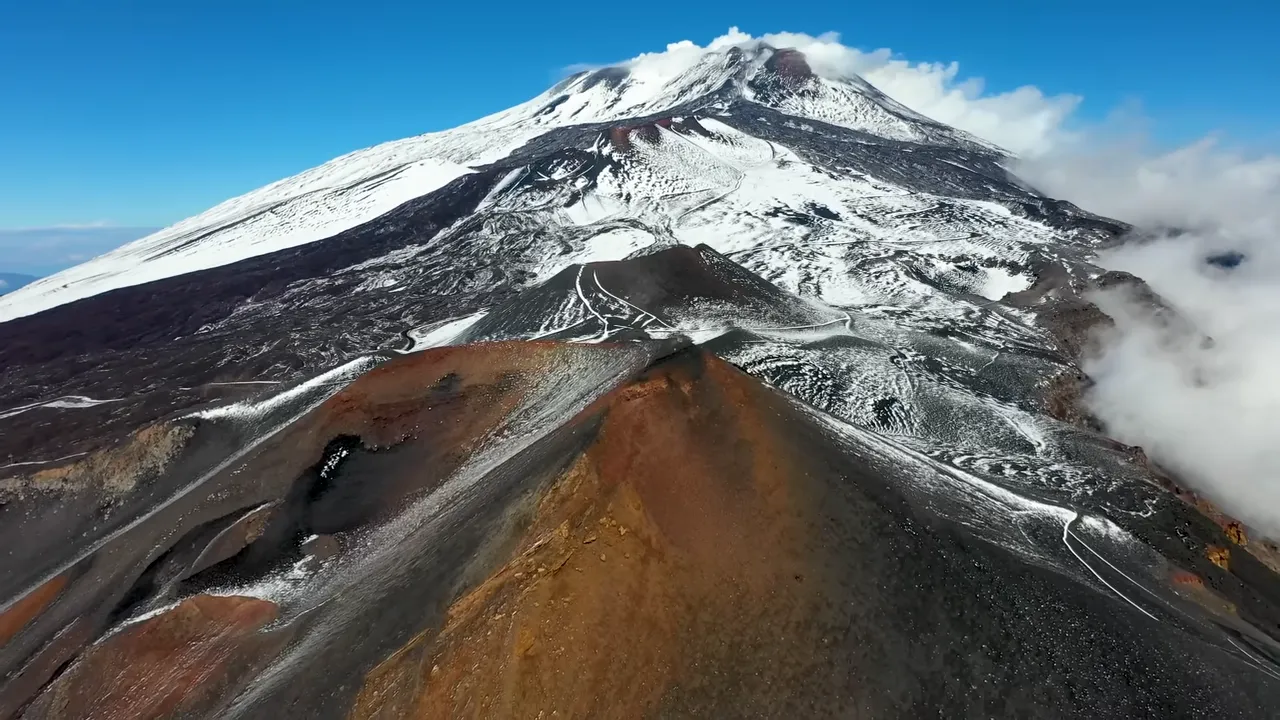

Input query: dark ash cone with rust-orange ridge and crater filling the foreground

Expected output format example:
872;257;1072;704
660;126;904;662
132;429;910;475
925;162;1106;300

10;343;1280;717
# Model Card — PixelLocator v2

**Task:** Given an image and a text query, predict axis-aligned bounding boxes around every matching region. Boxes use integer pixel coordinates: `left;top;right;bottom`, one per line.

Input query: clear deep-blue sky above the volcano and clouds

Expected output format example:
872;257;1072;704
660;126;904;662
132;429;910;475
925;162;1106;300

0;0;1280;233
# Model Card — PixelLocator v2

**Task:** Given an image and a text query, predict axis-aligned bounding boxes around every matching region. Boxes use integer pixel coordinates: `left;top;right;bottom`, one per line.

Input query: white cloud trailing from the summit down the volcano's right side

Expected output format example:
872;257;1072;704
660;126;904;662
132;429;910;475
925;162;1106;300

606;28;1280;527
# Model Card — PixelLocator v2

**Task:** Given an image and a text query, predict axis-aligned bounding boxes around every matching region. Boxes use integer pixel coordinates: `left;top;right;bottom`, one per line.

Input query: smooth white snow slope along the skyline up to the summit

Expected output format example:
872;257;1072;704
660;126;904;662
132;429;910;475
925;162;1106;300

0;40;989;322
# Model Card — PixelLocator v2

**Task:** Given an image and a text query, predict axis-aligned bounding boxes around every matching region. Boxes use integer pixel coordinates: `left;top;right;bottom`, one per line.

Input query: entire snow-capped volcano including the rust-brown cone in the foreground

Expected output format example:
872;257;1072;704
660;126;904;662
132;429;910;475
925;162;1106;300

0;41;1280;719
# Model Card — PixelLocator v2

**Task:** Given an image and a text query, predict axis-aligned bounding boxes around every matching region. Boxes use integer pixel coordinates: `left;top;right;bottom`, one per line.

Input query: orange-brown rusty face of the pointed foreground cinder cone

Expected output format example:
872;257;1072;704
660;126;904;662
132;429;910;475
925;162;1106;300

352;354;839;717
